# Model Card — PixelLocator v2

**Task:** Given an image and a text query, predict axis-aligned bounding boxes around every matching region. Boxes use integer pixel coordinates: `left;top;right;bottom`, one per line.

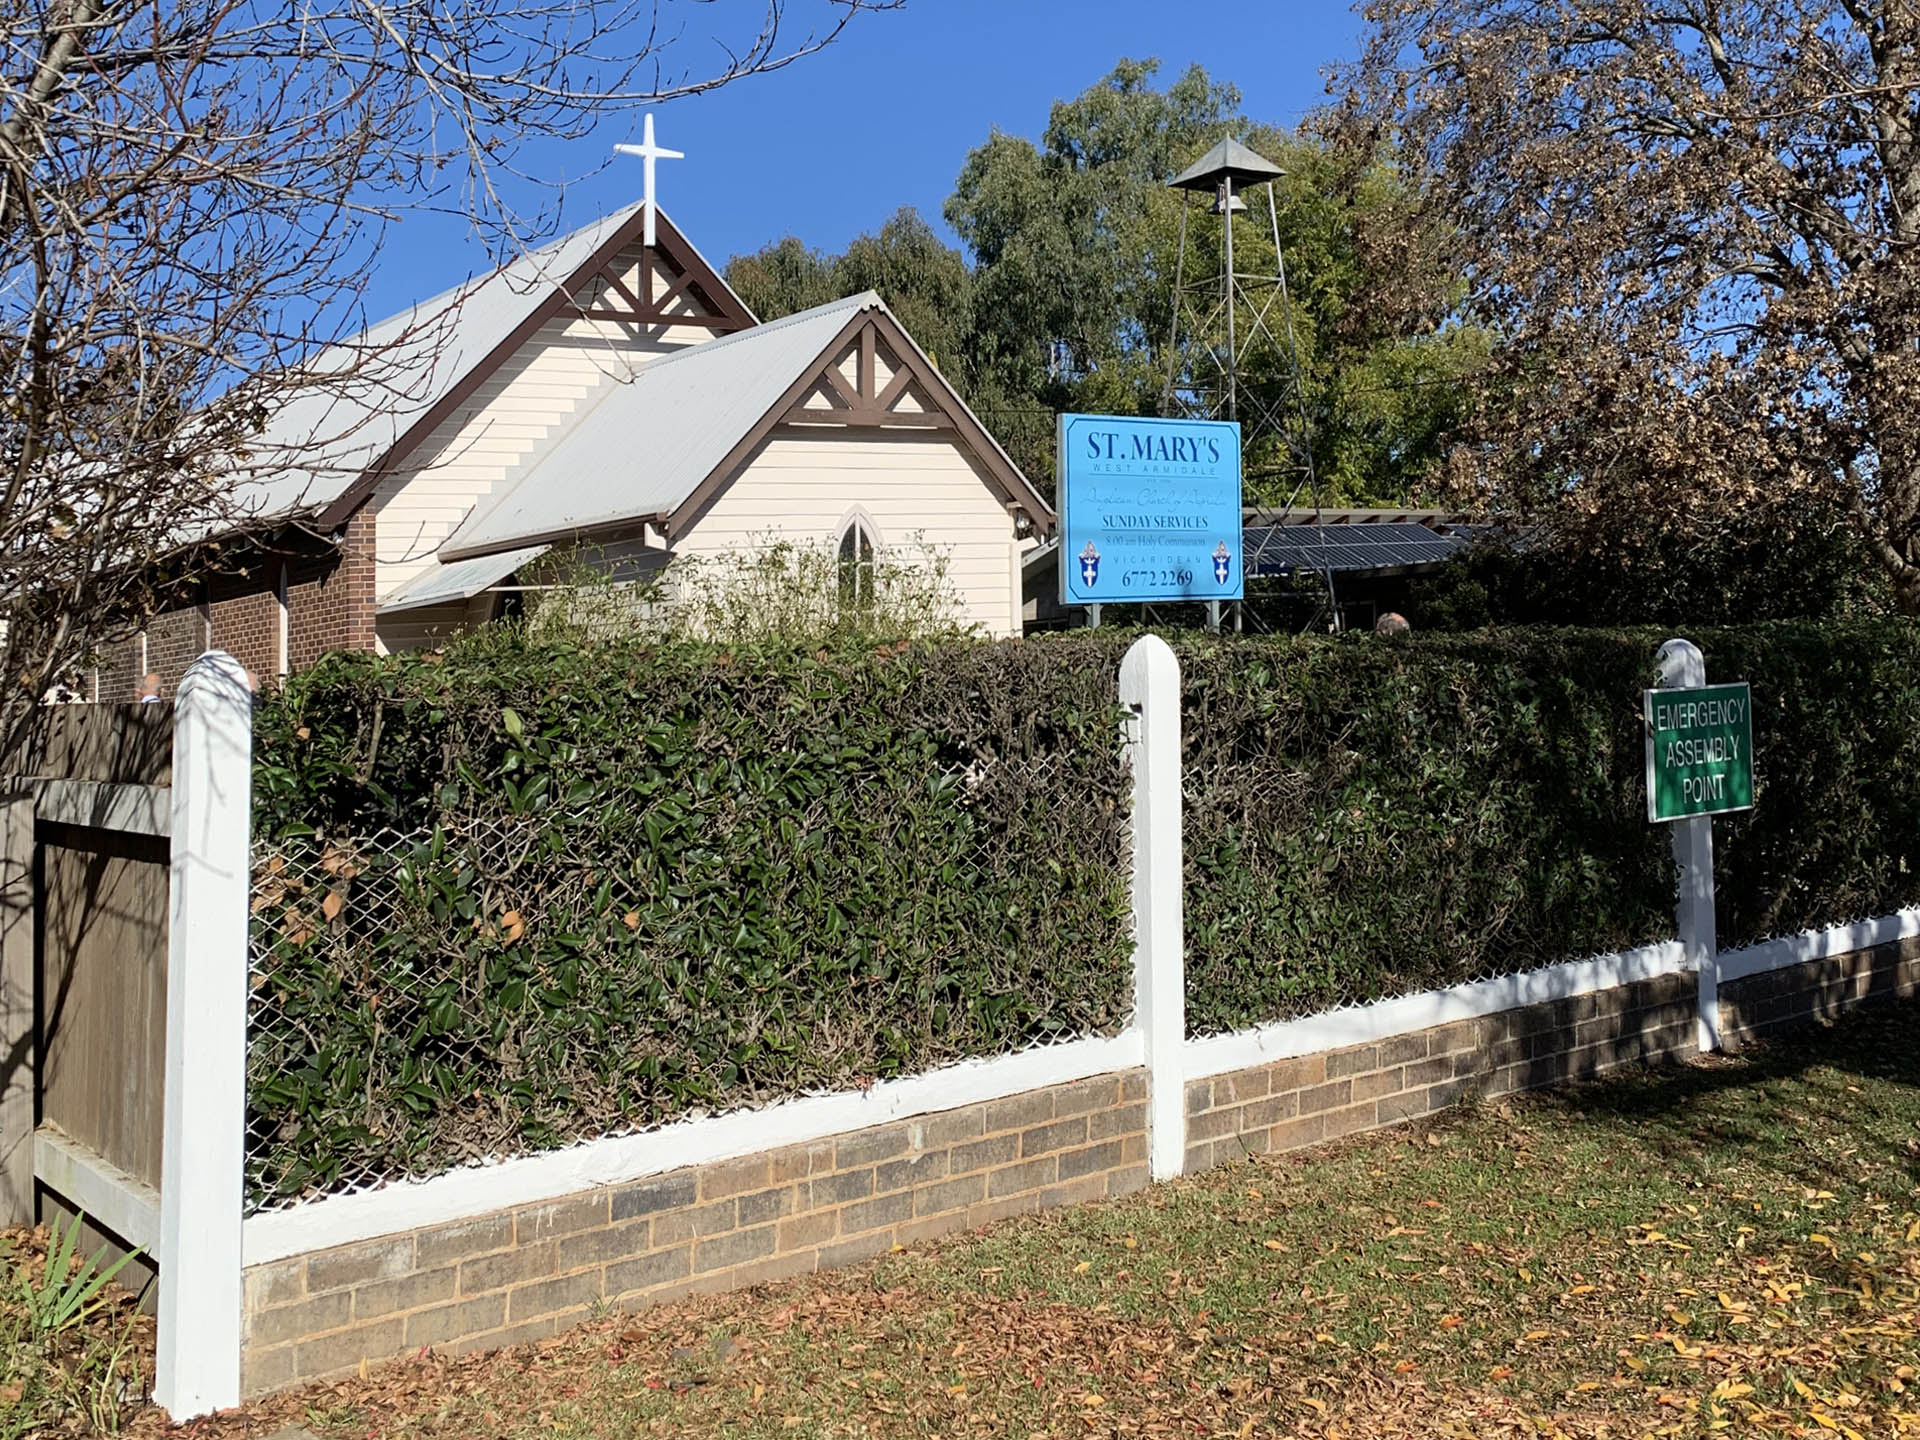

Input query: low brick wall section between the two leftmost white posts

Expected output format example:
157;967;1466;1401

242;1071;1146;1396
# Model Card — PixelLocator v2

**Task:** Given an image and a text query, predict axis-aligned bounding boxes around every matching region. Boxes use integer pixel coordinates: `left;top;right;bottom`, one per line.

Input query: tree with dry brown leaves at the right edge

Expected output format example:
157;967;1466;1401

1336;0;1920;612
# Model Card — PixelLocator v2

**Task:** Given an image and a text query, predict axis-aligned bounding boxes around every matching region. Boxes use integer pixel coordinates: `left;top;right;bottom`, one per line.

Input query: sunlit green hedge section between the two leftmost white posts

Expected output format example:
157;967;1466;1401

248;632;1131;1204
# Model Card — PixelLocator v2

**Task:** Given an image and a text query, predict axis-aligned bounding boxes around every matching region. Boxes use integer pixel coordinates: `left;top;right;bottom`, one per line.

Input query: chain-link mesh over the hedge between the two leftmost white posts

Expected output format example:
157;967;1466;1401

246;753;1131;1212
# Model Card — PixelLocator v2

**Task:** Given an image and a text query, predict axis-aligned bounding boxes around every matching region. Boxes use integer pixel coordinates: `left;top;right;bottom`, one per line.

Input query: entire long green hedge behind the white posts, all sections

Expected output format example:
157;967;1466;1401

250;622;1920;1202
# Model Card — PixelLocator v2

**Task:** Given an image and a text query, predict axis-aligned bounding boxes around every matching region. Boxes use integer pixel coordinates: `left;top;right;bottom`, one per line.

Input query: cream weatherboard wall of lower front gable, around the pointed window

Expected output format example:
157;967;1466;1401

674;426;1020;636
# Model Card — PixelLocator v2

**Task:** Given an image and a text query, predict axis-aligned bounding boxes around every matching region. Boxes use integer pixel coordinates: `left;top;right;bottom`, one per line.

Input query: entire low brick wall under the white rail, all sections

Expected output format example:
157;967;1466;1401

232;939;1920;1396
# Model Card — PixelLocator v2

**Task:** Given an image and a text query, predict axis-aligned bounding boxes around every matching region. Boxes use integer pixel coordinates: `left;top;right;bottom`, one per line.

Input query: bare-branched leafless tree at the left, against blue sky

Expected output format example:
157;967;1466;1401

0;0;883;755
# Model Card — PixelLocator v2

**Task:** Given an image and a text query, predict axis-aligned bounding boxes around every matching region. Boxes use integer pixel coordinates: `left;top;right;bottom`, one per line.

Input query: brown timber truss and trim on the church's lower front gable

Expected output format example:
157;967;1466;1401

657;300;1054;541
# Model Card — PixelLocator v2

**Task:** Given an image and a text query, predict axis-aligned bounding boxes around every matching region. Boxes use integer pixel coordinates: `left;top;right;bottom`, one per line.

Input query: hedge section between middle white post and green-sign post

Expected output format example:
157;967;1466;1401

1181;630;1672;1035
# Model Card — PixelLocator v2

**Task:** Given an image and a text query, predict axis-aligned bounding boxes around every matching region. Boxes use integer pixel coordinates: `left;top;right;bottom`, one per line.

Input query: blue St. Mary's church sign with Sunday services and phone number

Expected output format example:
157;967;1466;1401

1056;415;1244;605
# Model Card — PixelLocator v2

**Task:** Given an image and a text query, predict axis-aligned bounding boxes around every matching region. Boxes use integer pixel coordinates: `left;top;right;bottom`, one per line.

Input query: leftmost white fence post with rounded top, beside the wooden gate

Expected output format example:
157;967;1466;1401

154;651;253;1421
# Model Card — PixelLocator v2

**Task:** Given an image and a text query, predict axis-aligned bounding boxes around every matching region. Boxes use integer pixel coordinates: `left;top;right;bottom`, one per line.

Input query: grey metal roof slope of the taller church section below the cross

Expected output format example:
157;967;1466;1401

219;204;664;518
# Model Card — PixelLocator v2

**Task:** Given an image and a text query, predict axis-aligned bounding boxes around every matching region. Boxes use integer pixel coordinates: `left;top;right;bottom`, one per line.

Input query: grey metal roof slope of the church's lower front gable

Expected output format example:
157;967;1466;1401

440;290;885;555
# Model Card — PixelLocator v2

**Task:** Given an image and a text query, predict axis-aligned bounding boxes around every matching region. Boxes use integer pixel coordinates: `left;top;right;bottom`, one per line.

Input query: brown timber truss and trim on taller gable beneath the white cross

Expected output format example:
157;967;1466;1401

315;205;758;534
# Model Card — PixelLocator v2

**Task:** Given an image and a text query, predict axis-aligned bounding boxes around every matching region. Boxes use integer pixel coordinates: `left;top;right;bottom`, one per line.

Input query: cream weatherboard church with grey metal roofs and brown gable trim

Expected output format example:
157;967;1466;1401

96;159;1054;701
